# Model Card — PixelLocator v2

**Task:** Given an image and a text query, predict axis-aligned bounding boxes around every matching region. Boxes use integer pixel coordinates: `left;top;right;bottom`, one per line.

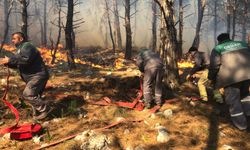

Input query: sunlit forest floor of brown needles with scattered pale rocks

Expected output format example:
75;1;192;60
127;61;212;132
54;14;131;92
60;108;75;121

0;49;250;150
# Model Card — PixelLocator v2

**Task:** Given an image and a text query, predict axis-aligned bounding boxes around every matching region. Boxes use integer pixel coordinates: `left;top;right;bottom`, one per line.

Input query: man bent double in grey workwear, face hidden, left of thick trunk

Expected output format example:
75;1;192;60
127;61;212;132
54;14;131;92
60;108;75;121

135;49;163;109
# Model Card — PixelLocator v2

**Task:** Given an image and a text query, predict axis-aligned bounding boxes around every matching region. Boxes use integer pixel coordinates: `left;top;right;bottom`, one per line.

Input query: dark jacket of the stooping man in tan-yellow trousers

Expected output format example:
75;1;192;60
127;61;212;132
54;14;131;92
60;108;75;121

190;51;207;75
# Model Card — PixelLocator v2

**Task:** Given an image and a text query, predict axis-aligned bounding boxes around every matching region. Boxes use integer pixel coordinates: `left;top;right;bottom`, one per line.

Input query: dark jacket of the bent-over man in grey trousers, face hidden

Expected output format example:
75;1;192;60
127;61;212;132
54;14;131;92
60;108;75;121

136;49;163;72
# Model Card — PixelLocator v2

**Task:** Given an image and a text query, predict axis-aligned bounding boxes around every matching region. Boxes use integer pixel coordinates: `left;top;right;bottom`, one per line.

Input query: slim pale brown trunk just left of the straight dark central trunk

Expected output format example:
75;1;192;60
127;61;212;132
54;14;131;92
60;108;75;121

113;0;122;49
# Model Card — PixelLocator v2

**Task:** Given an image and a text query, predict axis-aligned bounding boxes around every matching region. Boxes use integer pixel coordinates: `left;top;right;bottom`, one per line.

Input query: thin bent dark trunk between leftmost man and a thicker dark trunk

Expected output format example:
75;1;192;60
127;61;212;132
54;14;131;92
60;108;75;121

51;0;62;64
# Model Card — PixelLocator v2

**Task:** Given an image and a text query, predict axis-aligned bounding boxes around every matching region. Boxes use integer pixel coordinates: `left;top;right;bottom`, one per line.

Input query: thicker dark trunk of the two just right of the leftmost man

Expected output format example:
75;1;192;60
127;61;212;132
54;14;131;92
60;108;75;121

65;0;76;69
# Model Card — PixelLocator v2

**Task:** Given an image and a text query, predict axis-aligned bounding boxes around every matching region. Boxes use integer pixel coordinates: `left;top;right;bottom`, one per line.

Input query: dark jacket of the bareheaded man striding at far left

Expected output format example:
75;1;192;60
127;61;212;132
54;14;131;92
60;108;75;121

7;42;49;82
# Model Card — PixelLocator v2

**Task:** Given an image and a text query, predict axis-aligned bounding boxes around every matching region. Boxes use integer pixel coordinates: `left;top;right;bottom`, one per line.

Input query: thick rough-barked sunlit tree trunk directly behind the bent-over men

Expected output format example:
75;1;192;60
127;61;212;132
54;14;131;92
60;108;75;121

155;0;179;89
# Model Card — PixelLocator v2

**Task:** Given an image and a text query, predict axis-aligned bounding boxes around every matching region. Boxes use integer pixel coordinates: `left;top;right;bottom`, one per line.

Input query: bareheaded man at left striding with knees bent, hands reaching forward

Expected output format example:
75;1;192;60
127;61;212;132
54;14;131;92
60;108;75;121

0;32;51;120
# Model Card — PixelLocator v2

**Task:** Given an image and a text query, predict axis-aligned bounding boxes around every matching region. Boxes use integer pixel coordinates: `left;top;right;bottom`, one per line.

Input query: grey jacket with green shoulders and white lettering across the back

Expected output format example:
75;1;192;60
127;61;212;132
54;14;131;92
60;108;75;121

208;40;250;88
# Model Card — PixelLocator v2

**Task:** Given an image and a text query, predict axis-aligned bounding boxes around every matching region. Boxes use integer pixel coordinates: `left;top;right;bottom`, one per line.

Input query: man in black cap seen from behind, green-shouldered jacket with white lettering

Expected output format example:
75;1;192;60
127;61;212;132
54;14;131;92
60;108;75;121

208;33;250;130
